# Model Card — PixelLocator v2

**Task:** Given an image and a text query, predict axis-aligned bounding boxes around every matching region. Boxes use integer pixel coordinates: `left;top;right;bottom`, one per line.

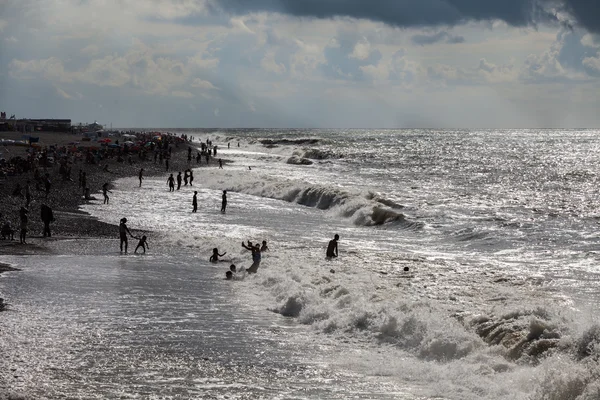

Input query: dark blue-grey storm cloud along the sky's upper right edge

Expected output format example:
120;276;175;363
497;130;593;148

212;0;600;32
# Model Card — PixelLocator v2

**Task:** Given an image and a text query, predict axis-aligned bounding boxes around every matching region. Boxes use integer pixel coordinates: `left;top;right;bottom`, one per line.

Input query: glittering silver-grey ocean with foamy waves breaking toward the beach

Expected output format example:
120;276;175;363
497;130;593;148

0;129;600;400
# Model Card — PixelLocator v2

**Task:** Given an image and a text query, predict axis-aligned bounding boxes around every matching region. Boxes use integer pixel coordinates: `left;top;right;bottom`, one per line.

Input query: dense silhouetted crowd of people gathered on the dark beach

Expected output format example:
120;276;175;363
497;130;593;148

0;132;202;243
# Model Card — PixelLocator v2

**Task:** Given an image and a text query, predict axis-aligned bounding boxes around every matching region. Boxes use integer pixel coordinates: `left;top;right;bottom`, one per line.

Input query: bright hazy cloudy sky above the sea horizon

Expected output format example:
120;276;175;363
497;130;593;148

0;0;600;128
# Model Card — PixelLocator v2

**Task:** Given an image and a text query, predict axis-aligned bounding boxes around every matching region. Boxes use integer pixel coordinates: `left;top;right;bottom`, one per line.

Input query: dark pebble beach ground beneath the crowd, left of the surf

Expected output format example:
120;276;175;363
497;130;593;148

0;132;218;255
